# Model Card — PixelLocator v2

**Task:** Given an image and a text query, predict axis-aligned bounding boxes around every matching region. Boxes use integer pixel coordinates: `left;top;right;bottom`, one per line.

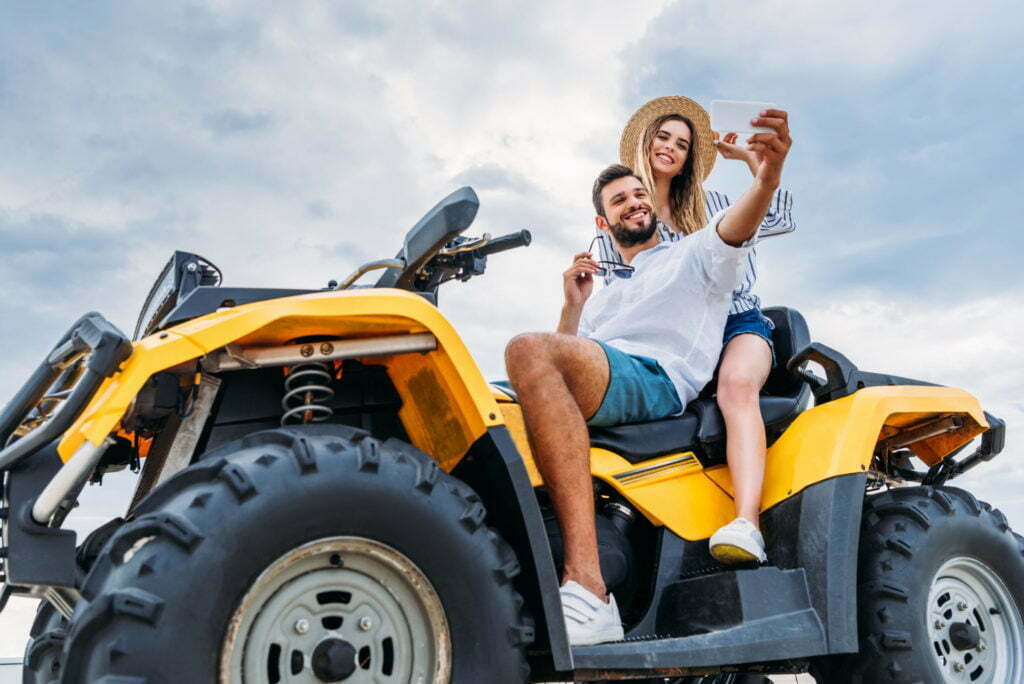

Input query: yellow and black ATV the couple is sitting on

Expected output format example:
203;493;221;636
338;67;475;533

0;188;1024;684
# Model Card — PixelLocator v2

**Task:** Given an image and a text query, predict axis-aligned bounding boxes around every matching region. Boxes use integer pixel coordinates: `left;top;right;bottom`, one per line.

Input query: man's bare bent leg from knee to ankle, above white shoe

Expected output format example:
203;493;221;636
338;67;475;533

505;333;608;599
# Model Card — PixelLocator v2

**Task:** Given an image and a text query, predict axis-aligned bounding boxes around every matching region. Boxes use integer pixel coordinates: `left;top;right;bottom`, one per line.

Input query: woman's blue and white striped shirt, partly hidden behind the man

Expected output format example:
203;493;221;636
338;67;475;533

597;189;797;314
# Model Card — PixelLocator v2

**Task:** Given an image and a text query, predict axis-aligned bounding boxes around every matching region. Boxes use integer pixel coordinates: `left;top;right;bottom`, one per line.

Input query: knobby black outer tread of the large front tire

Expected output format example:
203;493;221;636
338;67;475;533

60;426;534;684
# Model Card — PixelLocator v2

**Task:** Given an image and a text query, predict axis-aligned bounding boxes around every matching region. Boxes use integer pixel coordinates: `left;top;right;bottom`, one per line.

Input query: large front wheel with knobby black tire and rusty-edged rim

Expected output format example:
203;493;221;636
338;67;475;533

61;426;532;684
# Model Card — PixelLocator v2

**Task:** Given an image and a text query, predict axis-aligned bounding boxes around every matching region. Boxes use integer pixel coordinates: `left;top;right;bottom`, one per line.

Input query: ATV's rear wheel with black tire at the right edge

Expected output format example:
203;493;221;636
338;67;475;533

813;486;1024;684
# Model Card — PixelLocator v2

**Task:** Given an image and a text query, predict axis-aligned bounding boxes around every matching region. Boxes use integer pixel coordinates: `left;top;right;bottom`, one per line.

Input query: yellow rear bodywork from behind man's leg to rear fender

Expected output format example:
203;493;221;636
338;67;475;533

499;386;988;541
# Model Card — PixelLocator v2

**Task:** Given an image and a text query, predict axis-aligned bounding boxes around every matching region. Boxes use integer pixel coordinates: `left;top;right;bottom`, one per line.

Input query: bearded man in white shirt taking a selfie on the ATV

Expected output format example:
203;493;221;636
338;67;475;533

506;110;792;645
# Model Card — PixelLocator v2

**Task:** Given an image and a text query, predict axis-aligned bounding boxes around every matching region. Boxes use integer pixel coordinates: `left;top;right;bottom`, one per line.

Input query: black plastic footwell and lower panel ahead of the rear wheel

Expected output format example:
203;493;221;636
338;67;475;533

572;473;866;679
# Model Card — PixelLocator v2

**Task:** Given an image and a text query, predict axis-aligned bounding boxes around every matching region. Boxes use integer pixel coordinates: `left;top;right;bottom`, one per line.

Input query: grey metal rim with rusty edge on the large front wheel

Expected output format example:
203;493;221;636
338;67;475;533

220;537;452;684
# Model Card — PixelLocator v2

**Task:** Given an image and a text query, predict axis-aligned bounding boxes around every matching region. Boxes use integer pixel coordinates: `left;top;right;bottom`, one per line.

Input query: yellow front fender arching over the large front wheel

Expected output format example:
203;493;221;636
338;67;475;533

58;289;502;466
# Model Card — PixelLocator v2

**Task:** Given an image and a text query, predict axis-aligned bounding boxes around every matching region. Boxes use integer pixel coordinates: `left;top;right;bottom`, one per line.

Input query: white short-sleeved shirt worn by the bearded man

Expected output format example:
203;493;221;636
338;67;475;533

578;209;757;408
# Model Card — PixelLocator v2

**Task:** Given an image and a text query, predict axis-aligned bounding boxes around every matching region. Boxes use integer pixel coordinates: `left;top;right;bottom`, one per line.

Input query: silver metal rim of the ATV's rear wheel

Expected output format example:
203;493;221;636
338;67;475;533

927;557;1024;684
